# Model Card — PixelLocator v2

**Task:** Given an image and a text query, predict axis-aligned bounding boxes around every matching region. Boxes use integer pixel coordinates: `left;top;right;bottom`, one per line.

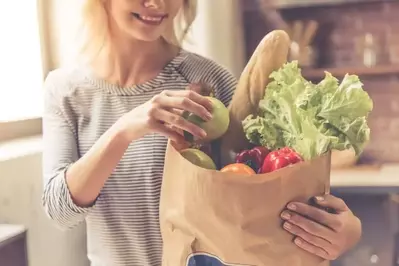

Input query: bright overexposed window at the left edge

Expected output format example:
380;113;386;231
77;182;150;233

0;0;43;141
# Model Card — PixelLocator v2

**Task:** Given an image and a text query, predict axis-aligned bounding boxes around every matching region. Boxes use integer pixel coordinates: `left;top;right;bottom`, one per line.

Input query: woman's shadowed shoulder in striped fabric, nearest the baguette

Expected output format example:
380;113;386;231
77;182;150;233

178;51;237;105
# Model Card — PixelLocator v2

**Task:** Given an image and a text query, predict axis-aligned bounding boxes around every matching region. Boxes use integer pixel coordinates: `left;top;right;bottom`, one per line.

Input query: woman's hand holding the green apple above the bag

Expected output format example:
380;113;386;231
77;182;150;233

117;90;216;142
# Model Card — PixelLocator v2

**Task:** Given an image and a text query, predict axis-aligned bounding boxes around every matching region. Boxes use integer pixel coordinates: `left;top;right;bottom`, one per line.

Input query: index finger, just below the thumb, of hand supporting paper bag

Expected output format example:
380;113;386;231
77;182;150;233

287;202;341;230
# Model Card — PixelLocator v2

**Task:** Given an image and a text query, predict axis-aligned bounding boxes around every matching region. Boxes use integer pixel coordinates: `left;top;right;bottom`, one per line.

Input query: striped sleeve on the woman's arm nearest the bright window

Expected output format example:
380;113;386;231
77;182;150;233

42;72;92;229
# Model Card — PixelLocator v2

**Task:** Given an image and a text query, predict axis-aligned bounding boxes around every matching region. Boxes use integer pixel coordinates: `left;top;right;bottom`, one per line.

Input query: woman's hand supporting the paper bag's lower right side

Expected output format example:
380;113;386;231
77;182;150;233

281;195;362;260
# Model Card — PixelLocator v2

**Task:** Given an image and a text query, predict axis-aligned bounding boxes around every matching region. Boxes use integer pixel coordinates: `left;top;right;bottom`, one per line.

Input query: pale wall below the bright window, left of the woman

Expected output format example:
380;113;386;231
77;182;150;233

0;138;89;266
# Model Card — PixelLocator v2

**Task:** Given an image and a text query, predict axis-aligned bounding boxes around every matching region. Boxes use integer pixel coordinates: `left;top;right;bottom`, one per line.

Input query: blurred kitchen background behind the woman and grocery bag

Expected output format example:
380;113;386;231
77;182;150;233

0;0;399;266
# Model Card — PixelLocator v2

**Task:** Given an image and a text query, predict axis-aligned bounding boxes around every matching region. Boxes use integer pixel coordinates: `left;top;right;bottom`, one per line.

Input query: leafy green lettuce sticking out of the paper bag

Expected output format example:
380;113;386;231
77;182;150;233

243;61;373;160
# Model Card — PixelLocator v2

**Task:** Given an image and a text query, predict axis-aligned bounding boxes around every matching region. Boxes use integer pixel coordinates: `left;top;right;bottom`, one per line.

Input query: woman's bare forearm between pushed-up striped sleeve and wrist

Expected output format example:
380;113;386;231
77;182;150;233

66;125;130;207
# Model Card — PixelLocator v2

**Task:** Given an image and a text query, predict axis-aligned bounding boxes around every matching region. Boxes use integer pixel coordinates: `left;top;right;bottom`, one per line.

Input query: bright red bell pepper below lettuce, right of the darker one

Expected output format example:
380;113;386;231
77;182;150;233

260;147;303;173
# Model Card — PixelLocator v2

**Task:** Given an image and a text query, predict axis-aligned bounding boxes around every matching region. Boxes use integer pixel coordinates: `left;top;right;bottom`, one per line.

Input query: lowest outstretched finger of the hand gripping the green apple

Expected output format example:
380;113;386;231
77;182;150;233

152;109;206;138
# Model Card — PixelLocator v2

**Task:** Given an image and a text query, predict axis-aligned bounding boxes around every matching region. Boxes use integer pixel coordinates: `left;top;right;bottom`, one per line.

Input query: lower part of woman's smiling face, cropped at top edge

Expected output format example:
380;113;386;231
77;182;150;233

108;0;184;41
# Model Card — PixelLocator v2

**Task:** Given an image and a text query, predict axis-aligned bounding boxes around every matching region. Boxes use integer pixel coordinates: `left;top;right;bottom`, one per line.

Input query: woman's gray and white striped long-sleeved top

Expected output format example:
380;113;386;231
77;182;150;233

43;50;237;266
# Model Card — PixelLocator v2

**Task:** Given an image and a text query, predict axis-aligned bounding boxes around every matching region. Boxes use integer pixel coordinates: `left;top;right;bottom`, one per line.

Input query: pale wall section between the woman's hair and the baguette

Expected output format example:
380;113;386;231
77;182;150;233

183;0;246;78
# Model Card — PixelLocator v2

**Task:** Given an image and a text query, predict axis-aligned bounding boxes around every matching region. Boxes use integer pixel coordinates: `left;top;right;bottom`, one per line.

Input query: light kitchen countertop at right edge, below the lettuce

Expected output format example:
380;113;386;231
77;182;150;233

331;164;399;194
